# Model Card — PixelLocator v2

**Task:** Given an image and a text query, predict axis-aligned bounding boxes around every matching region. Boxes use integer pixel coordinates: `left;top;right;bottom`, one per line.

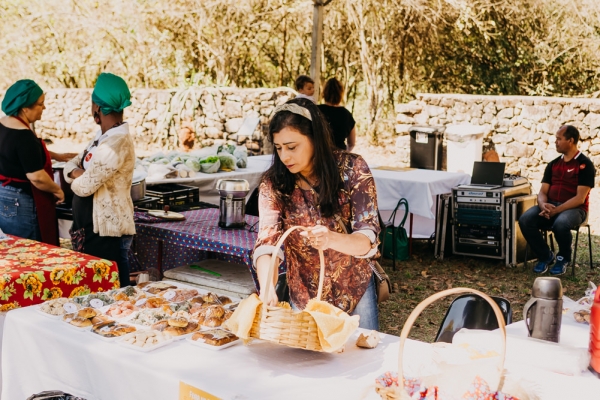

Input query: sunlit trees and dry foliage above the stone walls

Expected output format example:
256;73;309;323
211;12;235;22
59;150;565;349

0;0;600;135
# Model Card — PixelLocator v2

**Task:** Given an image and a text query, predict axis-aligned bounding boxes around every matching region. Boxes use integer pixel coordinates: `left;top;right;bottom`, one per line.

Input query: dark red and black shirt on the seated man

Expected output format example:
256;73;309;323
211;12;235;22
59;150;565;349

542;152;596;211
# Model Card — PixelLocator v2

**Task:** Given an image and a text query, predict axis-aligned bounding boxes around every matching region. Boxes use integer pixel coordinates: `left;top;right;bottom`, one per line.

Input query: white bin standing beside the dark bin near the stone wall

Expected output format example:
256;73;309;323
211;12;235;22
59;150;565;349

446;124;483;175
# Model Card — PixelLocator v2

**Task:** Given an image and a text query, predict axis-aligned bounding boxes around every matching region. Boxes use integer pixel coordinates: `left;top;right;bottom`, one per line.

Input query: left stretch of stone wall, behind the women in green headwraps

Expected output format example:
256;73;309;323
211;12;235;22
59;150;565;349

0;88;296;155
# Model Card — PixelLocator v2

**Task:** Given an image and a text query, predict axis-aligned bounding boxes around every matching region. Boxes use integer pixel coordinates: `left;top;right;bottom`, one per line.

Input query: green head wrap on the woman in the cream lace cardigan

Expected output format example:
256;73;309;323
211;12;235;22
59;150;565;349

92;72;131;115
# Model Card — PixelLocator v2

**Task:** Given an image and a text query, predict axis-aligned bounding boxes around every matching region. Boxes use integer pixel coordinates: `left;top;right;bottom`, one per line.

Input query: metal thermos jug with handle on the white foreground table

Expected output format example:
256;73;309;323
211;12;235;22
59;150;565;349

523;277;562;343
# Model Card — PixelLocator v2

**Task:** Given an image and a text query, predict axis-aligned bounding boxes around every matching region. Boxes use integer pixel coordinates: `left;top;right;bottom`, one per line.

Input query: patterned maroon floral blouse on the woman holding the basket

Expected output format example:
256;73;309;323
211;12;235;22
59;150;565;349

254;151;381;313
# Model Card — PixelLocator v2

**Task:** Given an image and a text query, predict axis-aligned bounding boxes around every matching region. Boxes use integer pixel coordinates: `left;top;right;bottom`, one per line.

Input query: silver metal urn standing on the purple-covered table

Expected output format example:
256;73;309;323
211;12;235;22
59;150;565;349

217;179;250;229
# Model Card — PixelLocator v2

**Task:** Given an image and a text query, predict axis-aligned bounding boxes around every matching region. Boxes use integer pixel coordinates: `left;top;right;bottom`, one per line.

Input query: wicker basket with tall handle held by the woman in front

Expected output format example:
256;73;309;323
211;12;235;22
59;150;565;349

250;226;325;351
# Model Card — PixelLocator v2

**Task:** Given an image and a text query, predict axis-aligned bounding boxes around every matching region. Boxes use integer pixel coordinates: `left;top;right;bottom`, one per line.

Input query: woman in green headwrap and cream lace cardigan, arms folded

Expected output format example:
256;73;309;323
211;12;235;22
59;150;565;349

64;73;135;286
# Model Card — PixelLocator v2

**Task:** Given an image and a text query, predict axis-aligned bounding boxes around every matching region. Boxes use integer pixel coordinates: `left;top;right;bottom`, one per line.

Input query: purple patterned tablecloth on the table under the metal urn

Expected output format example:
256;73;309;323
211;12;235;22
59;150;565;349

132;208;274;288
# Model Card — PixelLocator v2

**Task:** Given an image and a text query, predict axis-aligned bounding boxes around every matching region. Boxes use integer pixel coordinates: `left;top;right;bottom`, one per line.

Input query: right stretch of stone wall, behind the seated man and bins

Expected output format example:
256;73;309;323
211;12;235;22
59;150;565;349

396;94;600;182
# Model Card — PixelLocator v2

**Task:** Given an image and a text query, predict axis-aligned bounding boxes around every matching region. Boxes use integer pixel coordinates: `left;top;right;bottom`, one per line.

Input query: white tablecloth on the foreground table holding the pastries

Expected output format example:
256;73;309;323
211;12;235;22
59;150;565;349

2;307;430;400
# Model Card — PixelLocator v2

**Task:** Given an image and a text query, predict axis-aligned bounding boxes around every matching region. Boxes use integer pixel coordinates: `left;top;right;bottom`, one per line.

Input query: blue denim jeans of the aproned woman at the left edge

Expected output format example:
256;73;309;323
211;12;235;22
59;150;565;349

0;185;41;240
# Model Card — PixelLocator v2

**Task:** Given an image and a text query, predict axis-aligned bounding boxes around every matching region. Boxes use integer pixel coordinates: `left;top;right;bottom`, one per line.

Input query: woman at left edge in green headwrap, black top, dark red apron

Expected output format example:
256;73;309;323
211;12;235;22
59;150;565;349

0;79;65;245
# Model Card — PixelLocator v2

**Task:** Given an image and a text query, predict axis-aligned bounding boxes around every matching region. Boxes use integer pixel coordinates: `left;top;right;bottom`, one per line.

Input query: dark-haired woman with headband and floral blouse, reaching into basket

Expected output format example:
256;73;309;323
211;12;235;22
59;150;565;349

254;99;380;329
